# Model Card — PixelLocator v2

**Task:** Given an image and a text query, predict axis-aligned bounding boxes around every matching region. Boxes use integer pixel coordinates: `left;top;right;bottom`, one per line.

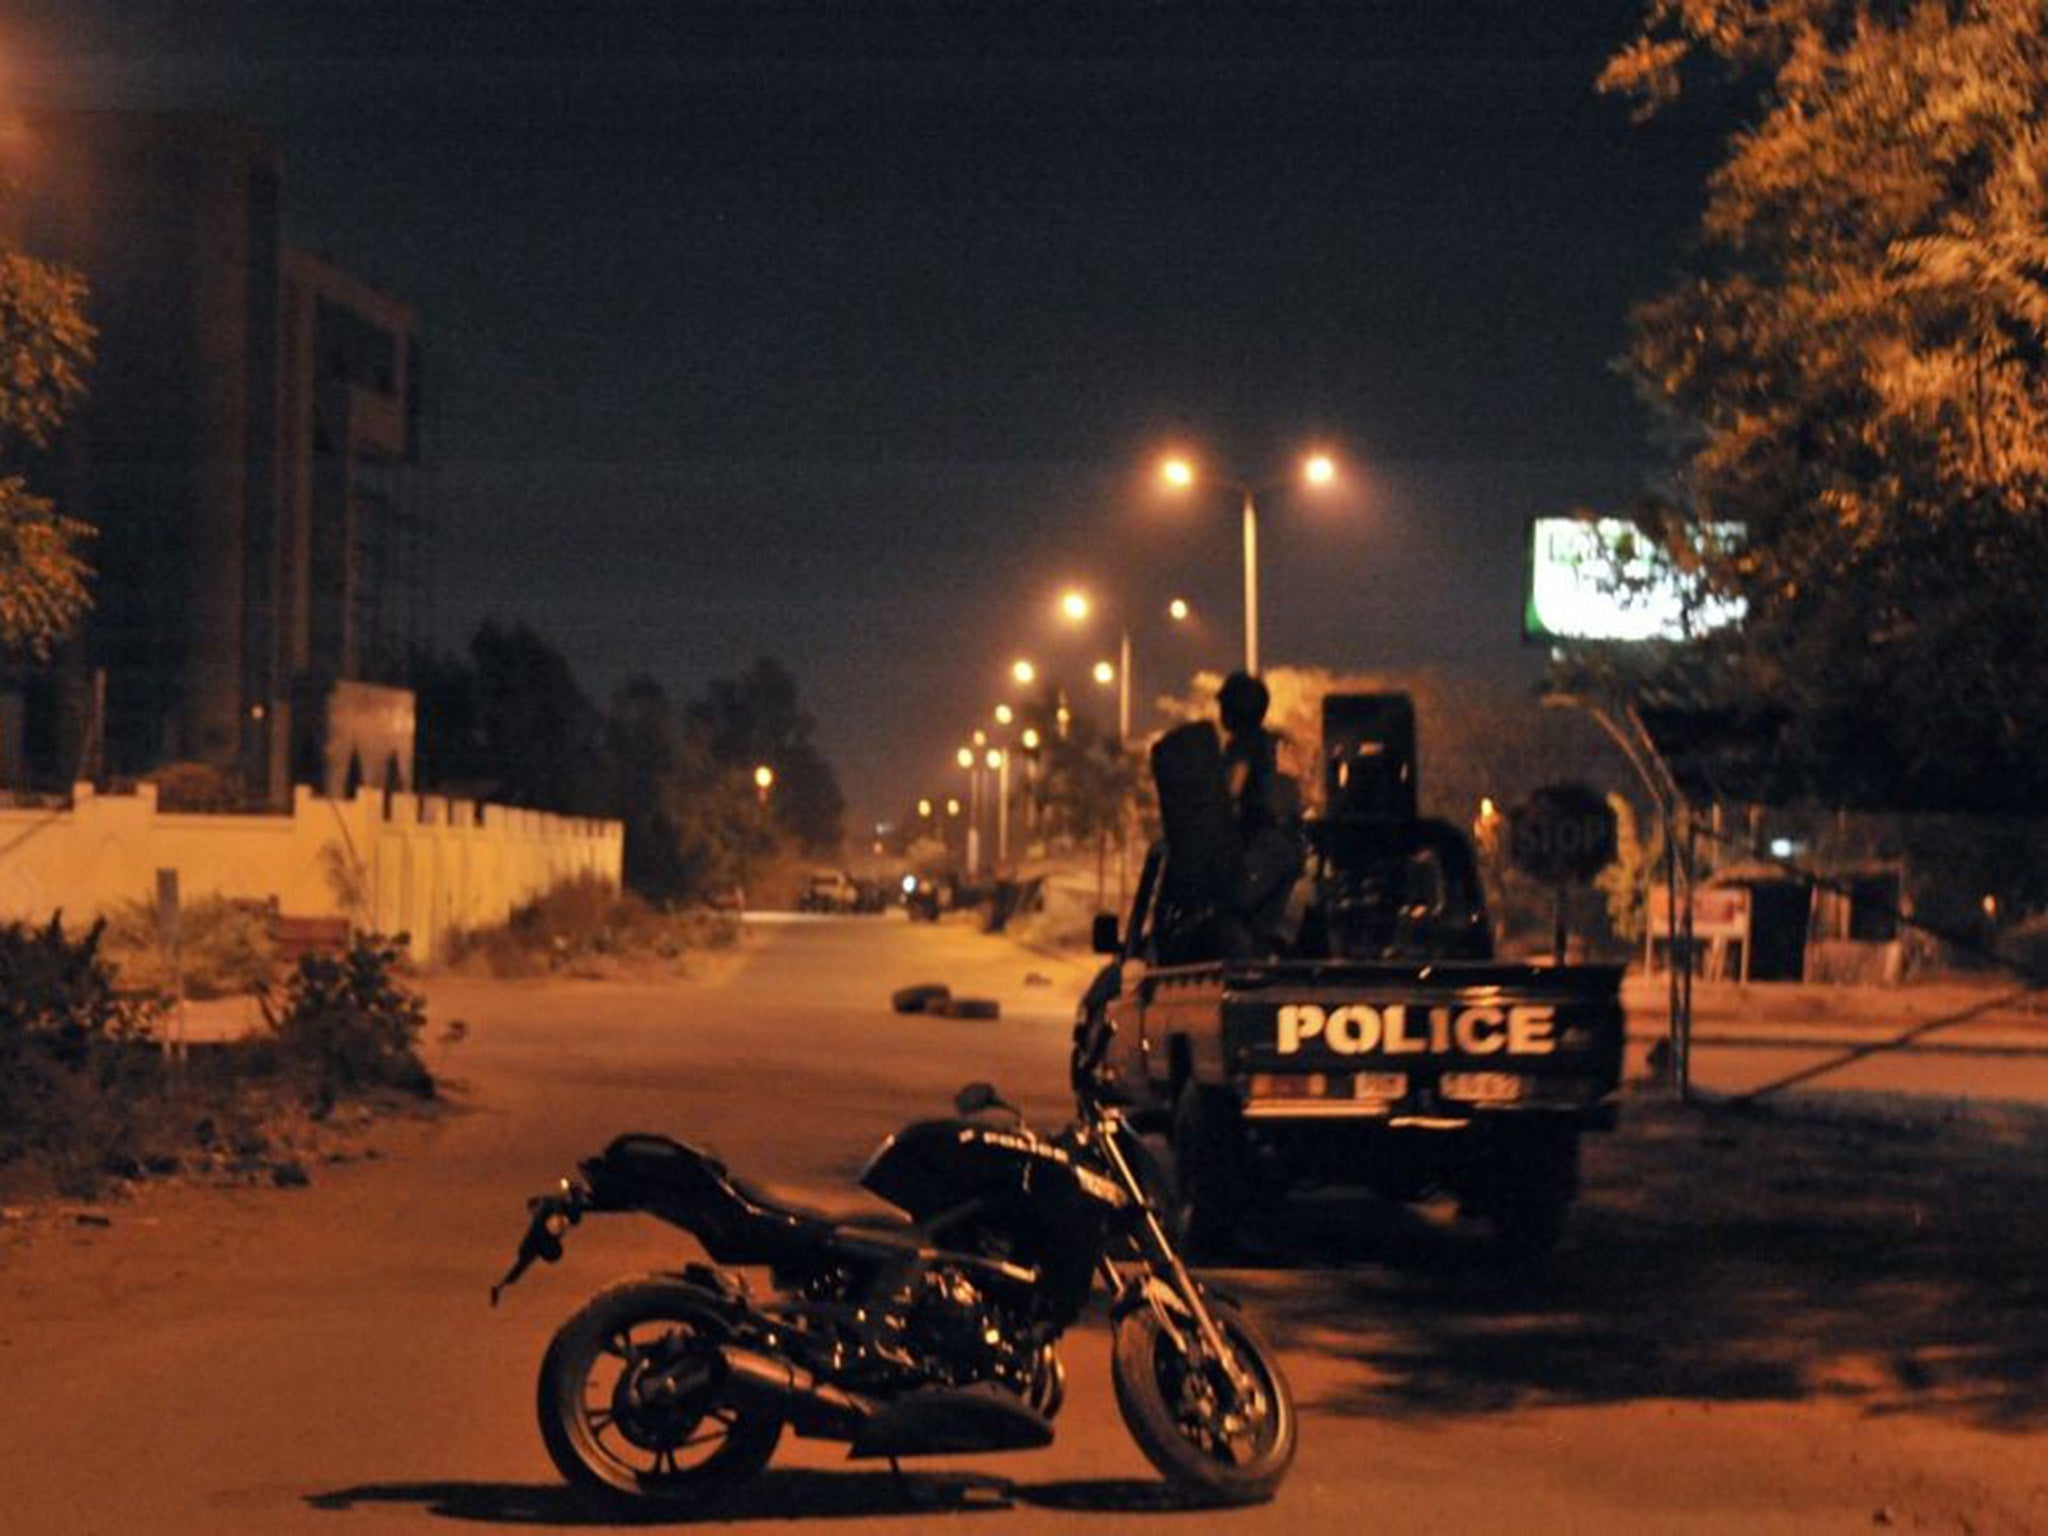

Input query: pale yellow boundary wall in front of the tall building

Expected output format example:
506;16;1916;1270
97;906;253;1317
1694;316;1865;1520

0;784;625;961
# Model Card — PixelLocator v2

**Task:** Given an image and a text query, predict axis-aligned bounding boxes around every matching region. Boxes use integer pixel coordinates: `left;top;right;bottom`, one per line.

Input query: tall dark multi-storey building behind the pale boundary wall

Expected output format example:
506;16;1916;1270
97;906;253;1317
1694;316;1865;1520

0;113;426;805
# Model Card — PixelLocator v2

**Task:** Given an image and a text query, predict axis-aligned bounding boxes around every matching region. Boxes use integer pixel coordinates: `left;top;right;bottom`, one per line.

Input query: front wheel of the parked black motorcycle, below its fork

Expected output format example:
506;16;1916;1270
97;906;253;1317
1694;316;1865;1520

1112;1298;1294;1503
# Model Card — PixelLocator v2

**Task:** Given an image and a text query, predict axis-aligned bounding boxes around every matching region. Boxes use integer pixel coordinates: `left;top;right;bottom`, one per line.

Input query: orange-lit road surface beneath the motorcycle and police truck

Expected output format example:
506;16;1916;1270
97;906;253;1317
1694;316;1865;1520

0;920;2048;1536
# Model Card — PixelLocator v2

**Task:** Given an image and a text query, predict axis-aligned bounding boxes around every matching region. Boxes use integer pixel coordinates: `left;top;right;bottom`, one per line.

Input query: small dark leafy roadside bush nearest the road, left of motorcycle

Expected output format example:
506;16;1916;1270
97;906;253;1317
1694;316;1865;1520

264;934;434;1110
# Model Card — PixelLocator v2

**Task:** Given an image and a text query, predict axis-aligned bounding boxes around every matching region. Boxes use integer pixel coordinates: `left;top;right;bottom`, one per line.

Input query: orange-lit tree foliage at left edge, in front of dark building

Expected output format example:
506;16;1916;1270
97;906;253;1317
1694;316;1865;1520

0;211;94;655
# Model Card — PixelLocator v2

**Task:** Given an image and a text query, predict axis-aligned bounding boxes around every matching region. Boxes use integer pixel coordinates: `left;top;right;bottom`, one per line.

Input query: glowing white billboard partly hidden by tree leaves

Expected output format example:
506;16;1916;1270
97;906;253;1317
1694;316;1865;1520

1522;518;1743;641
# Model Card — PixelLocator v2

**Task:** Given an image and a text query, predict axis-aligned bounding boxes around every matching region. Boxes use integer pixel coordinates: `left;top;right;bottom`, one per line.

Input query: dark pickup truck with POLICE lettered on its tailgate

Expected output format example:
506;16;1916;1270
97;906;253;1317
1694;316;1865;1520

1075;700;1624;1257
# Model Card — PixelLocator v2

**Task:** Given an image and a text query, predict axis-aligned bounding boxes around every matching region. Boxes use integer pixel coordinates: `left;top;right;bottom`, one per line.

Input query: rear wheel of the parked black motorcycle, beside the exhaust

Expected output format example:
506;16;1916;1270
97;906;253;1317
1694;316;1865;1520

537;1280;782;1505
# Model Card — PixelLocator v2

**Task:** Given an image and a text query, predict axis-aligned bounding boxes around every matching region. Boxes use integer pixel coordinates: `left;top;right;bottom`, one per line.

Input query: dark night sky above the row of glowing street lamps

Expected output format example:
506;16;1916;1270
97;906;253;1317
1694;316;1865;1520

0;0;1712;831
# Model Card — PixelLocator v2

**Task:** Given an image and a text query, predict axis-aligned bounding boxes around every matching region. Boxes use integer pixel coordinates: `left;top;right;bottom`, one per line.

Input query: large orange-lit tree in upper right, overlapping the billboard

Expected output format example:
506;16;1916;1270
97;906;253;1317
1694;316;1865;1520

1602;0;2048;807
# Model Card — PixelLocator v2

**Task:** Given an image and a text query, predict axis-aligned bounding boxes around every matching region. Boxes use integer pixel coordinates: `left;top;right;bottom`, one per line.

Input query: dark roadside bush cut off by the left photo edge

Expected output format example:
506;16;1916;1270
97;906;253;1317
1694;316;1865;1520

0;913;164;1182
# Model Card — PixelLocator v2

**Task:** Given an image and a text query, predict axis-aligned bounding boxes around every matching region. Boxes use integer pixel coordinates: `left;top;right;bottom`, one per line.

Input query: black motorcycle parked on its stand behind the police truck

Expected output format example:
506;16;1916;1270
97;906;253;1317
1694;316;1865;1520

492;991;1296;1507
